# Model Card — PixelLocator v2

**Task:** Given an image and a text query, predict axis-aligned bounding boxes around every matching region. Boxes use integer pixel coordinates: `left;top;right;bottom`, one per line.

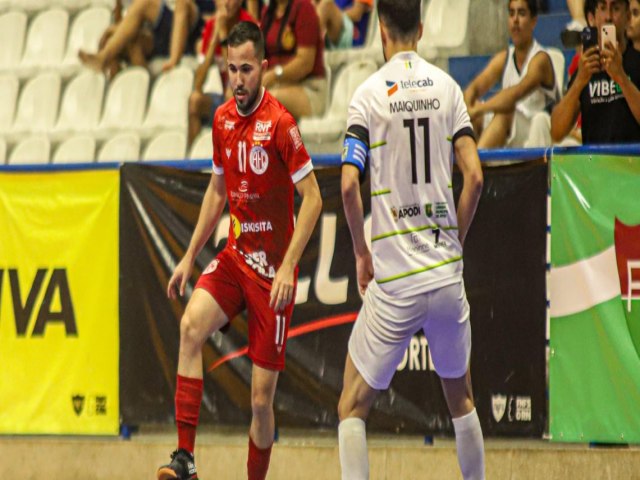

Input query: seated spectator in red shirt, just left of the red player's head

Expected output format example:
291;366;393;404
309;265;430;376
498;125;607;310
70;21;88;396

189;0;257;145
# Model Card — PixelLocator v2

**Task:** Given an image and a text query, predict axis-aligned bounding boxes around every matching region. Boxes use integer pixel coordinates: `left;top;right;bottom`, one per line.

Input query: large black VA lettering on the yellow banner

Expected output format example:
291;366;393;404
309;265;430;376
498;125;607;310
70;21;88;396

0;268;78;338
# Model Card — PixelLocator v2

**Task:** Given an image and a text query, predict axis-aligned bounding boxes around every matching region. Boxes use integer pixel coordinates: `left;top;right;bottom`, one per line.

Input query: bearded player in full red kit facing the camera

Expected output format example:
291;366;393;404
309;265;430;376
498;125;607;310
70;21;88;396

157;22;322;480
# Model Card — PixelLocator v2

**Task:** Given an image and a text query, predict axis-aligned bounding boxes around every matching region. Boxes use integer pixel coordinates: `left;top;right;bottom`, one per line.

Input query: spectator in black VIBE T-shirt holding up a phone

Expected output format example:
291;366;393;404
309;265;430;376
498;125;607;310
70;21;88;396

551;0;640;145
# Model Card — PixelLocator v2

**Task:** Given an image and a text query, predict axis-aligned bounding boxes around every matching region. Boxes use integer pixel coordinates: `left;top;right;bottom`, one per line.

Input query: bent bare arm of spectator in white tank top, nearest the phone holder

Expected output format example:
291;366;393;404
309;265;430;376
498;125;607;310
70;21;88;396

469;52;555;120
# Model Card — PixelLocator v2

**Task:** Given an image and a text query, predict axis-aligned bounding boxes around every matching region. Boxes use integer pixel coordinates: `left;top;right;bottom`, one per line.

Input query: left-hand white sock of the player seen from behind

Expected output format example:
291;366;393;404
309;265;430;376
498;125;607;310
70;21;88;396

338;417;369;480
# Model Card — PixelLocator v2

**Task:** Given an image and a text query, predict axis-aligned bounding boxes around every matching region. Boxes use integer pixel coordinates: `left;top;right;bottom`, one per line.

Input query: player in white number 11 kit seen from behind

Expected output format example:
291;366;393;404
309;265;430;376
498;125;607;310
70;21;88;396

338;0;484;480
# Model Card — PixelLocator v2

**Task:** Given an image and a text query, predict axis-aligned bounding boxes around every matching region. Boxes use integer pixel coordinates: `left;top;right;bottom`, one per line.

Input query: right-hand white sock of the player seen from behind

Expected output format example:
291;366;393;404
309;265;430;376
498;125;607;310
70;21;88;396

453;408;484;480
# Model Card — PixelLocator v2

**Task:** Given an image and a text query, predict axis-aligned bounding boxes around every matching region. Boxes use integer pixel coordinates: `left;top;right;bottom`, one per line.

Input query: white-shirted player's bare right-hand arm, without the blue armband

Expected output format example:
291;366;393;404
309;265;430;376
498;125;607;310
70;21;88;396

454;135;483;245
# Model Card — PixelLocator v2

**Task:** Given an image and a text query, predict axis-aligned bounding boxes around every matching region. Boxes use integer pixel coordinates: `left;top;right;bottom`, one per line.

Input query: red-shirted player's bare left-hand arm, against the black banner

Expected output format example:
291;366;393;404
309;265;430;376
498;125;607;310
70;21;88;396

167;172;227;300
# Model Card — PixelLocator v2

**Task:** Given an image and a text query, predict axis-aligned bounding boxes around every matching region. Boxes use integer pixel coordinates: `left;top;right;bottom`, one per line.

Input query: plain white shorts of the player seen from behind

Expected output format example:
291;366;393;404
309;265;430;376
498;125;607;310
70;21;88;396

349;280;471;390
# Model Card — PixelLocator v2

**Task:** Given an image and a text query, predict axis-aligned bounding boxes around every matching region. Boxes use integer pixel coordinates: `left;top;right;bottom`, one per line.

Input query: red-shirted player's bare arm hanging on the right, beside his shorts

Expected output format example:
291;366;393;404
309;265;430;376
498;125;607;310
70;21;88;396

269;171;322;312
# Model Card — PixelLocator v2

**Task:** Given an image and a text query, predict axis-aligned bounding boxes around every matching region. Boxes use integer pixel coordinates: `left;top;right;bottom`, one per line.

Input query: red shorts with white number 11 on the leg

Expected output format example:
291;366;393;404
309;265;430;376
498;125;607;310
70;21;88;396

196;249;295;370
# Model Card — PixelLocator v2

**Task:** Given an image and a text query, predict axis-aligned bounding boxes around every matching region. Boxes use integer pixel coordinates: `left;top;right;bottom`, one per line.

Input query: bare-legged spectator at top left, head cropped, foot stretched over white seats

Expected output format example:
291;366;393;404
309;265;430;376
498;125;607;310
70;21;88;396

78;0;211;71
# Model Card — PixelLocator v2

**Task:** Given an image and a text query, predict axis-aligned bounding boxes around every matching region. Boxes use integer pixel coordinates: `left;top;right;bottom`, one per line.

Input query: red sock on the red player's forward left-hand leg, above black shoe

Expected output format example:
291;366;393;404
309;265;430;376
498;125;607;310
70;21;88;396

176;375;203;453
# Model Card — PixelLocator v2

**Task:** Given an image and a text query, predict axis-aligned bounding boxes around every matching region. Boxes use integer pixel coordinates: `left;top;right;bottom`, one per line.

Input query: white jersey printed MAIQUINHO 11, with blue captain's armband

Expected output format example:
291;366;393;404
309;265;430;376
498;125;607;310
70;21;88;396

343;52;473;297
